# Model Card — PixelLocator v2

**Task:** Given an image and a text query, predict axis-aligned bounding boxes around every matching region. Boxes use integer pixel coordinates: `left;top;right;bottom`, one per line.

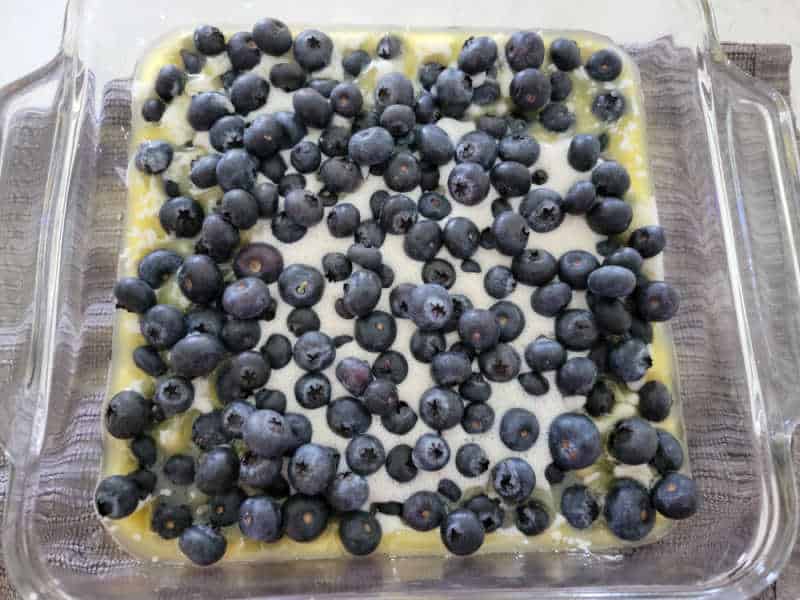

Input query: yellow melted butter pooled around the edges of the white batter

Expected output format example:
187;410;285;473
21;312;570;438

103;30;682;562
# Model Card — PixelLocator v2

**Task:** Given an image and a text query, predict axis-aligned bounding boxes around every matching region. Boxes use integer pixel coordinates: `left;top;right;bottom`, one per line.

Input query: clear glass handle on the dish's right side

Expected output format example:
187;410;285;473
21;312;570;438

712;56;800;441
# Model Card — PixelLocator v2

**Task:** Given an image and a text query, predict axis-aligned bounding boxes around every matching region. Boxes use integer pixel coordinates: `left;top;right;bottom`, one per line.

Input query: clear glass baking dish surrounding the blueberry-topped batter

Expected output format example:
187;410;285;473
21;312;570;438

0;0;800;599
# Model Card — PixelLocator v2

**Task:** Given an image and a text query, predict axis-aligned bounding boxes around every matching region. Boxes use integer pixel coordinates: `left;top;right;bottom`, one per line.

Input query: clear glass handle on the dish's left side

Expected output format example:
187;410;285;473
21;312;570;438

0;55;65;461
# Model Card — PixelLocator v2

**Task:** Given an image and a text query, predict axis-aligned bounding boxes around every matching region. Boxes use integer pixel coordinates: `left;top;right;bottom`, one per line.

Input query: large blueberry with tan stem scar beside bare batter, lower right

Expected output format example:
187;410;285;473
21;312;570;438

547;413;602;471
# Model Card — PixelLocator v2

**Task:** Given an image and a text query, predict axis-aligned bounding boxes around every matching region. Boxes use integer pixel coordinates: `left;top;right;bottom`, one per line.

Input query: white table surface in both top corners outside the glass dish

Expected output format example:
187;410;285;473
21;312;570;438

0;0;800;114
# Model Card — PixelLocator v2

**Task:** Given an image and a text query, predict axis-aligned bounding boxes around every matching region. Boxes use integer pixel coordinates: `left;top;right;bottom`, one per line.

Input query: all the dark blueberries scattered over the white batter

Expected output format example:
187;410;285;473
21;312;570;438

96;19;697;565
